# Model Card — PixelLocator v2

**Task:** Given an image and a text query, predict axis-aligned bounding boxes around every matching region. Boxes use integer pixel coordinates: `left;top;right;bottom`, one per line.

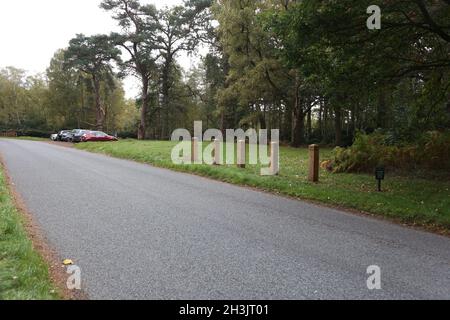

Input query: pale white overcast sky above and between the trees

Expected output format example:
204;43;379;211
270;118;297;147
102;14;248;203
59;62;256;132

0;0;195;97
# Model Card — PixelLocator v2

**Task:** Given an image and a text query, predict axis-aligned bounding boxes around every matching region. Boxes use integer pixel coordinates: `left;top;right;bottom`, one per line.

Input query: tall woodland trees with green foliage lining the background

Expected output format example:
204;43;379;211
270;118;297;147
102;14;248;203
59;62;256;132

0;0;450;146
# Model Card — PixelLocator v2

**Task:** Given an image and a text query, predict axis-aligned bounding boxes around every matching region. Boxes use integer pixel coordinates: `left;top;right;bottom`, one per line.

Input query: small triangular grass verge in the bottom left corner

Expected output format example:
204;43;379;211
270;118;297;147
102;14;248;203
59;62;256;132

0;168;59;300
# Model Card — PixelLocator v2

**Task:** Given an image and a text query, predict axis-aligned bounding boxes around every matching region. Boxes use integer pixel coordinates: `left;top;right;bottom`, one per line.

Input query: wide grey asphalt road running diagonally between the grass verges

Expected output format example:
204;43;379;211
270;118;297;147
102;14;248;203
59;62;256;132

0;139;450;299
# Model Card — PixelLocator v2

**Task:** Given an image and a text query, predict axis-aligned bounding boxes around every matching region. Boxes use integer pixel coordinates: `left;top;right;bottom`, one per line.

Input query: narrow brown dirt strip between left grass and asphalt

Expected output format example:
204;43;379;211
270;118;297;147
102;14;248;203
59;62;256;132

0;155;88;300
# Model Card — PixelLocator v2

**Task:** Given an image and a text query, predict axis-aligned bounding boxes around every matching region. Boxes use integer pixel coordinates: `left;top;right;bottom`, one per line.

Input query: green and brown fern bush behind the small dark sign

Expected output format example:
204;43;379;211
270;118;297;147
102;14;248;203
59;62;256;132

333;131;450;172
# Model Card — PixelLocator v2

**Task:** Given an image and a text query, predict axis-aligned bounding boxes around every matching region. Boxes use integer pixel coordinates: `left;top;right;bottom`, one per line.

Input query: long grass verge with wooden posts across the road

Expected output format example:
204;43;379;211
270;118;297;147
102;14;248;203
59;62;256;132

76;140;450;233
